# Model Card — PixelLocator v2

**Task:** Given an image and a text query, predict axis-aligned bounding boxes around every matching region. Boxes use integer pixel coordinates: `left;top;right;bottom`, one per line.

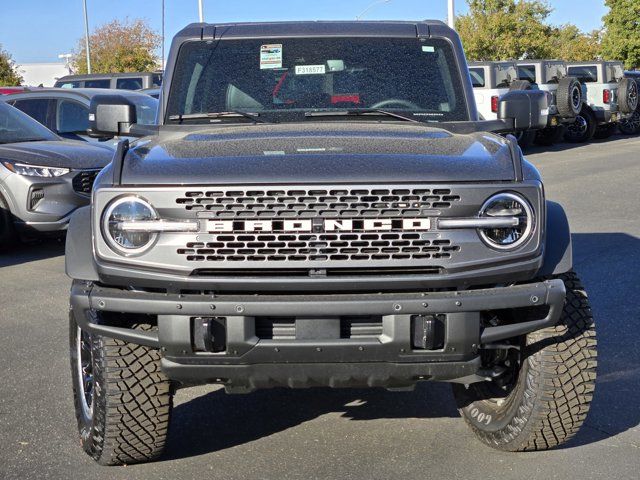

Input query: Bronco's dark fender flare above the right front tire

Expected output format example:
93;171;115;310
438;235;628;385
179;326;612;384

538;200;573;277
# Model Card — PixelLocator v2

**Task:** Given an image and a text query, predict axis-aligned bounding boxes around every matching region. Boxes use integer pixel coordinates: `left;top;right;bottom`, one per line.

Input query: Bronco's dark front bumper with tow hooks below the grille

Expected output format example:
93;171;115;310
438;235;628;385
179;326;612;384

71;280;565;392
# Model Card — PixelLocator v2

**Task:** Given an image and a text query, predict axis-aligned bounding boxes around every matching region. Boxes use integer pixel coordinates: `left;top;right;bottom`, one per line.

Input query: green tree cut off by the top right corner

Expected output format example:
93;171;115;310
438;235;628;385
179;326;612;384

602;0;640;69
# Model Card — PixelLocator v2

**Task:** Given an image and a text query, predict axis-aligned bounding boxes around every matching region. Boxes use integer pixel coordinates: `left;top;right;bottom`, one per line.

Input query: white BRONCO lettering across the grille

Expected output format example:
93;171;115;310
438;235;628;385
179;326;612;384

206;218;431;233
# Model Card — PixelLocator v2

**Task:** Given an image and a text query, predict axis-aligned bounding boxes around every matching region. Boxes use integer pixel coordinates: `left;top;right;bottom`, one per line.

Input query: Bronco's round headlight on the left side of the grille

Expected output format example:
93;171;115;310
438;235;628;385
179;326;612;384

102;196;158;255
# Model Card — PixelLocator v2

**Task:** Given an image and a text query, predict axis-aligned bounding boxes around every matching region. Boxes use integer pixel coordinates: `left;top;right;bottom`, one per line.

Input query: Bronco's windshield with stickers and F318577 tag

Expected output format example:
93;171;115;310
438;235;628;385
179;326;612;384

166;38;469;122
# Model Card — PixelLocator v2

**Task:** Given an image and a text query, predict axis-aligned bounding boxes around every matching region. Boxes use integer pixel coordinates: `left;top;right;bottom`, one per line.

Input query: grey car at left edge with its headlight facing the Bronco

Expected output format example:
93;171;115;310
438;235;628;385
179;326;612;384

0;101;113;244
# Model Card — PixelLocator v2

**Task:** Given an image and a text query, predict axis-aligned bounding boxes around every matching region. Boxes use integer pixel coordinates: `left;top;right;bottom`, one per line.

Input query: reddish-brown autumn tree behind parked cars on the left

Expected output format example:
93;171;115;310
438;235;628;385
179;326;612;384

72;19;161;74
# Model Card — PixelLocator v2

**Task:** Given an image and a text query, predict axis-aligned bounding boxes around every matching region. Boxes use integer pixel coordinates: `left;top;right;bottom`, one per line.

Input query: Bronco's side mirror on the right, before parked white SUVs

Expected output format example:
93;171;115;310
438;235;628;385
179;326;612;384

498;90;549;131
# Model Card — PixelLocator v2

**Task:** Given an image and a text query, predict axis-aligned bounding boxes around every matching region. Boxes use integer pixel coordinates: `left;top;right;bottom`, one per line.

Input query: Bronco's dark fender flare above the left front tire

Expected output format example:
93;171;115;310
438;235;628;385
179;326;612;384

64;206;99;282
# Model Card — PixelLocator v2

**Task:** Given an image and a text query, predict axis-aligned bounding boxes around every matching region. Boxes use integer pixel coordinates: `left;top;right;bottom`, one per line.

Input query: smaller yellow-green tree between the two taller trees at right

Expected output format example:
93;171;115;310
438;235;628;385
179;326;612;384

549;23;601;62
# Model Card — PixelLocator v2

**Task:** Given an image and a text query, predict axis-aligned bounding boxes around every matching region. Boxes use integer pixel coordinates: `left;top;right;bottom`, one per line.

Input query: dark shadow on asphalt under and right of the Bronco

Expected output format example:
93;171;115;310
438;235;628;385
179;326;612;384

165;233;640;459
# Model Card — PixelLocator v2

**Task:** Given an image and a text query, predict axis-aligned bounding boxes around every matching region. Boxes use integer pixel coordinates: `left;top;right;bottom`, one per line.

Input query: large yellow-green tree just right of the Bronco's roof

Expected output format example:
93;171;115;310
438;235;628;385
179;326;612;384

456;0;552;60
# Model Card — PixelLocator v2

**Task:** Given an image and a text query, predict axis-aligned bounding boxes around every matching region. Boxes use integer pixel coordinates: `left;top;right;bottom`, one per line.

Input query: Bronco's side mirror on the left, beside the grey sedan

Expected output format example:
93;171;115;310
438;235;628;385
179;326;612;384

89;95;137;137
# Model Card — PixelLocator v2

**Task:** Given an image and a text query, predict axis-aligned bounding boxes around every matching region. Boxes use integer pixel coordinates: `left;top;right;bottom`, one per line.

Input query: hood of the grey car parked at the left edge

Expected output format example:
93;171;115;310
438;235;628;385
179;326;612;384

0;140;113;170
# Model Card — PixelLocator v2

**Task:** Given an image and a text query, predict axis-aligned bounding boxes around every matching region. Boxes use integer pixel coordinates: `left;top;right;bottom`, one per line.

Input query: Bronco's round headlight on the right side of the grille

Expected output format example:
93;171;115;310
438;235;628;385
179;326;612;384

478;193;535;250
